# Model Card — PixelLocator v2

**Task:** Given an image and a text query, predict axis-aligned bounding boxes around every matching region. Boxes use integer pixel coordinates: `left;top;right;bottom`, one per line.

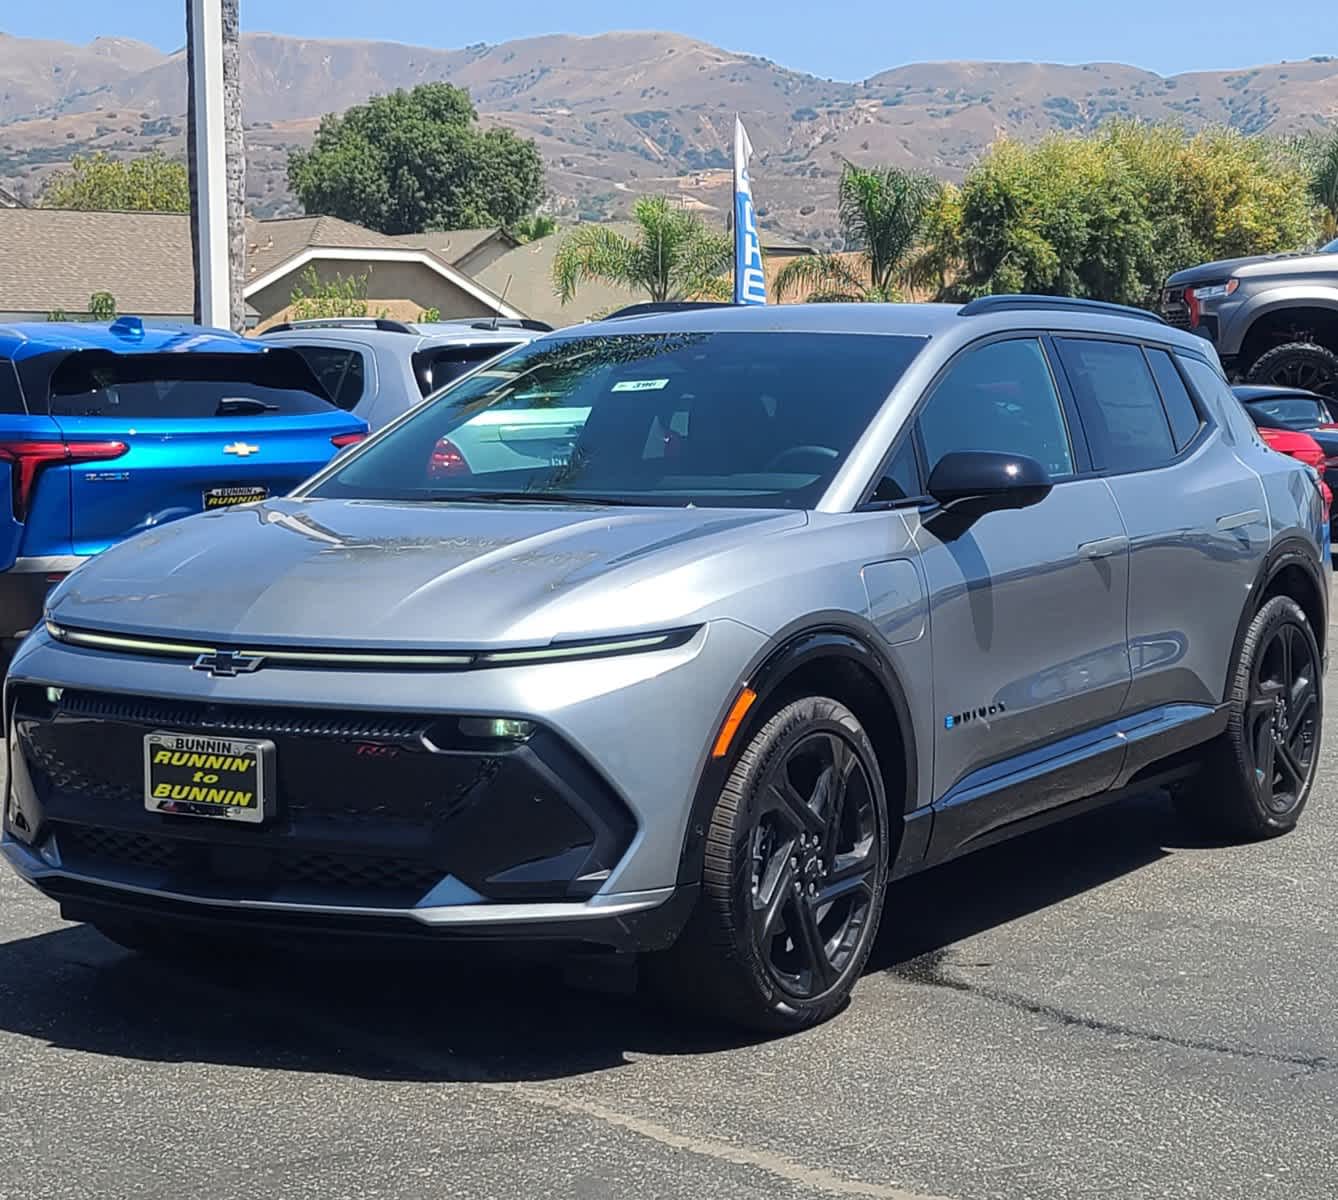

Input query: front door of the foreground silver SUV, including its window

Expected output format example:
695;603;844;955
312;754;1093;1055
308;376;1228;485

915;337;1131;858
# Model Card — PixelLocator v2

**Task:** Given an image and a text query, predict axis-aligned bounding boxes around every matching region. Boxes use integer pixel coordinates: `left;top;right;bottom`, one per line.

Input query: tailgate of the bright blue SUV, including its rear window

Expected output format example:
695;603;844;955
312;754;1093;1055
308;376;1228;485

47;349;365;554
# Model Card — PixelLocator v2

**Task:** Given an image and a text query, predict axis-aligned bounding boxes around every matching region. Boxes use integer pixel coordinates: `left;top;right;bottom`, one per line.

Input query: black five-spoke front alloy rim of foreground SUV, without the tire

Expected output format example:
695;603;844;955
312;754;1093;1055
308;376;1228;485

749;730;882;999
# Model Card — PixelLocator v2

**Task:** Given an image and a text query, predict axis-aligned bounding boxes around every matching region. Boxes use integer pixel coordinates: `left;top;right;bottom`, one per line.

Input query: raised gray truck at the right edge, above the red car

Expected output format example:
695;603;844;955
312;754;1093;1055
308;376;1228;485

1161;241;1338;400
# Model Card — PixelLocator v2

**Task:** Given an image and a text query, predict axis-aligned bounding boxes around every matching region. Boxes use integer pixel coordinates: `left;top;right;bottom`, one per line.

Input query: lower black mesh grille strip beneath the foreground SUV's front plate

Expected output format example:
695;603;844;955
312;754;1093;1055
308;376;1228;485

56;823;442;898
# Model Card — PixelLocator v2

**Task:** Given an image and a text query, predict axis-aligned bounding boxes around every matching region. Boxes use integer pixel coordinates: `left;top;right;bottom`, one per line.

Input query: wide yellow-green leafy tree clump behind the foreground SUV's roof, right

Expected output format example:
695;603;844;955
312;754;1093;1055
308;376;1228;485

937;120;1315;305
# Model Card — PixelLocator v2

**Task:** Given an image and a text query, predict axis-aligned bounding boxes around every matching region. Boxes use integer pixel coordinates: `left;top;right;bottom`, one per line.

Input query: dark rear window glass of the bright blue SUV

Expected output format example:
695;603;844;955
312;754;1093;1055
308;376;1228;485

45;351;333;419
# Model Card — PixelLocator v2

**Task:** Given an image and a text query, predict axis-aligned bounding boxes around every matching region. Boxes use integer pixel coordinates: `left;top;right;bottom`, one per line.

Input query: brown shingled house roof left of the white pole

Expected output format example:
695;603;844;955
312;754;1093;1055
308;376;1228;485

0;207;195;317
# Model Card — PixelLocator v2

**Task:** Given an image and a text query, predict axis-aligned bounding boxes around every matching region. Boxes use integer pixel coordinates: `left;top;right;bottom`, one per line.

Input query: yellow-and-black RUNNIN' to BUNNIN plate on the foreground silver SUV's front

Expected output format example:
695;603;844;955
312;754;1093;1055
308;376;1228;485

145;733;274;824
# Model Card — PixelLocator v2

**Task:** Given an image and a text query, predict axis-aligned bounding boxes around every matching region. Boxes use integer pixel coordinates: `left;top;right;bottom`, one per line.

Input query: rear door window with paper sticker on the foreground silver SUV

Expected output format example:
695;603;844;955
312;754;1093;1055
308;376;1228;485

1058;338;1176;471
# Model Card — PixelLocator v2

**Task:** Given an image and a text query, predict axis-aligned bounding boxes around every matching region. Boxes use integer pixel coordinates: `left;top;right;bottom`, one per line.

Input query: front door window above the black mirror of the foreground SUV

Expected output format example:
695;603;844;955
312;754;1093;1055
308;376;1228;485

918;337;1073;478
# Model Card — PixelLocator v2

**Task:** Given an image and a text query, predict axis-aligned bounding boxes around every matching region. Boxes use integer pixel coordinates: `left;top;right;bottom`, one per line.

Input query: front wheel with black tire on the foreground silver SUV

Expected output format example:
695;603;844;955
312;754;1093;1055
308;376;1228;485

649;696;888;1033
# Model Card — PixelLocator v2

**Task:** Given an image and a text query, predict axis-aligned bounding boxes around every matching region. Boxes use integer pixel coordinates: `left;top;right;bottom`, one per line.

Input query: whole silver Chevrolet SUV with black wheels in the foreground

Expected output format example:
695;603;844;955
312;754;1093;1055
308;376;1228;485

3;297;1329;1030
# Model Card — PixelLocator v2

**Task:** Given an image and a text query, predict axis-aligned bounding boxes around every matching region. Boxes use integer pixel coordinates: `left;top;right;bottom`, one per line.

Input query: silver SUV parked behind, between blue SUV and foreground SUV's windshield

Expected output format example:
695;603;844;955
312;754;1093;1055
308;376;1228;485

260;317;551;429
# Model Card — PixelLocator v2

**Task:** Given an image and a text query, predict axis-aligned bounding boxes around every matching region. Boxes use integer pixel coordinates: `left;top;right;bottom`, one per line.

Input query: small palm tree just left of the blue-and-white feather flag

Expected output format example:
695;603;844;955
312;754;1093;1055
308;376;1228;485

553;195;733;304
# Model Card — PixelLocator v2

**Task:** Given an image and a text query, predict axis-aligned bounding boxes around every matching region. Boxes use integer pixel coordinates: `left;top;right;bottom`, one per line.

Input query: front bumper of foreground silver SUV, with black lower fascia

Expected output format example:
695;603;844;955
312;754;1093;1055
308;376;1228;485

4;622;759;948
